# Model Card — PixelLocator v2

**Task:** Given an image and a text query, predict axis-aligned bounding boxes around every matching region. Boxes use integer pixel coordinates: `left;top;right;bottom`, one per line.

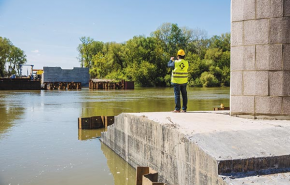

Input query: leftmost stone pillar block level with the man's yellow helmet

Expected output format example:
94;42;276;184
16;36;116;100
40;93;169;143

231;46;244;71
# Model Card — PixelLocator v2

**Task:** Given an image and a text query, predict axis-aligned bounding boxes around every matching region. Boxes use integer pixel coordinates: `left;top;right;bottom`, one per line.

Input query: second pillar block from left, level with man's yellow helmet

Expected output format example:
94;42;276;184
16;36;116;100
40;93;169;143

243;46;256;70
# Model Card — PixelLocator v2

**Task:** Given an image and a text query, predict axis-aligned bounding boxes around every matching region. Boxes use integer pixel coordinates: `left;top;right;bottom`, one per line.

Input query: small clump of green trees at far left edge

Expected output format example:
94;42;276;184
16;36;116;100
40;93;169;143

0;37;27;77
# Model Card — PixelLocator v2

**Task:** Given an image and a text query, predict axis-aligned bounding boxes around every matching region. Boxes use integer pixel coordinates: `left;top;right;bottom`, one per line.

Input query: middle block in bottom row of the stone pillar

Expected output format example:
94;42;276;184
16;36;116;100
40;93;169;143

255;96;282;114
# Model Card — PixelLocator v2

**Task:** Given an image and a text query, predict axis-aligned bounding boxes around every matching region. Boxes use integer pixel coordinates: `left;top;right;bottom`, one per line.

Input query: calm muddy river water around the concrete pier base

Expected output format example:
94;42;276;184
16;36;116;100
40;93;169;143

0;88;229;185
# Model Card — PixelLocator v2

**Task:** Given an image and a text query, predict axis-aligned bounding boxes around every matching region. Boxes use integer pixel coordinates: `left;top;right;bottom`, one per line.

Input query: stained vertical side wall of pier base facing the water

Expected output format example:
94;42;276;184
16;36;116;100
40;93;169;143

102;114;226;185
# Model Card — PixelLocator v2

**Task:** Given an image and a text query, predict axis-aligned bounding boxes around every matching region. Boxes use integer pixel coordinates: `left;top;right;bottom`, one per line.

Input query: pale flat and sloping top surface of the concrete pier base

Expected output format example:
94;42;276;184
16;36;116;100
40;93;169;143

132;111;290;160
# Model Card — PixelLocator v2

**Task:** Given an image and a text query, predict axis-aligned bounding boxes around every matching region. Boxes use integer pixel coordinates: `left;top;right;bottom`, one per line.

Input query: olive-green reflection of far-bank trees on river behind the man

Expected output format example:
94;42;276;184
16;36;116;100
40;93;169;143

82;88;229;117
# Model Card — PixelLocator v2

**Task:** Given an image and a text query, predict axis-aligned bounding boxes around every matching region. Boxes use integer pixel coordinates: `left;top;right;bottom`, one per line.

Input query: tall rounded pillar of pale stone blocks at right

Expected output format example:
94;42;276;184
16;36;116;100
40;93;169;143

230;0;290;119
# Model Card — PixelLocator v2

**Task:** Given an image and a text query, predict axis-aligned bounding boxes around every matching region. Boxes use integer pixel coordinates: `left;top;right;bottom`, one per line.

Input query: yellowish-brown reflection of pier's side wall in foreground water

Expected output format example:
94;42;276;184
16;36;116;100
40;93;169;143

101;143;136;185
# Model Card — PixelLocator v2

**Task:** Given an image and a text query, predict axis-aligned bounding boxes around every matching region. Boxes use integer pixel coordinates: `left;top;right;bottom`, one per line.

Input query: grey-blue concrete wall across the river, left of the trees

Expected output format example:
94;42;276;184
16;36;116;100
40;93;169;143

42;67;90;86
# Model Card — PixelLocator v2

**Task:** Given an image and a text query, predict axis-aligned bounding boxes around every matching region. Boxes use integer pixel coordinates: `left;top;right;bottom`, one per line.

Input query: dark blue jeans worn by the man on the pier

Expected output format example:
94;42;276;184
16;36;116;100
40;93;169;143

173;84;187;110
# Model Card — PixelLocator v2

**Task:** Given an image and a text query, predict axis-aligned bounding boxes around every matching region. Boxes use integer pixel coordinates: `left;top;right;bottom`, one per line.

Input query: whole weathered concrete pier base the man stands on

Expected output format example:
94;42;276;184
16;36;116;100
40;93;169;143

101;112;290;185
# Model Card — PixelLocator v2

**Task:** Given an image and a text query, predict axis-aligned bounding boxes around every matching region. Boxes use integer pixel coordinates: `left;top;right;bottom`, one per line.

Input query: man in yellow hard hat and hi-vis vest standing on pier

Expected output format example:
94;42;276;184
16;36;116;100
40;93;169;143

168;49;188;113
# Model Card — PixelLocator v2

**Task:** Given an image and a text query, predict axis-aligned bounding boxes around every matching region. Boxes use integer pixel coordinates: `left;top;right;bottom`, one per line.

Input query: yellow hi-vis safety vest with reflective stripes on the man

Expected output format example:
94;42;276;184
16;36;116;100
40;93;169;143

171;59;188;84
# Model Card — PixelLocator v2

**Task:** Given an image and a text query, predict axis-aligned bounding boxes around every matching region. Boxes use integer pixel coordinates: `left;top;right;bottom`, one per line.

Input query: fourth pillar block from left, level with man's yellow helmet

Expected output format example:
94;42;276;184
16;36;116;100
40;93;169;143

269;44;283;70
